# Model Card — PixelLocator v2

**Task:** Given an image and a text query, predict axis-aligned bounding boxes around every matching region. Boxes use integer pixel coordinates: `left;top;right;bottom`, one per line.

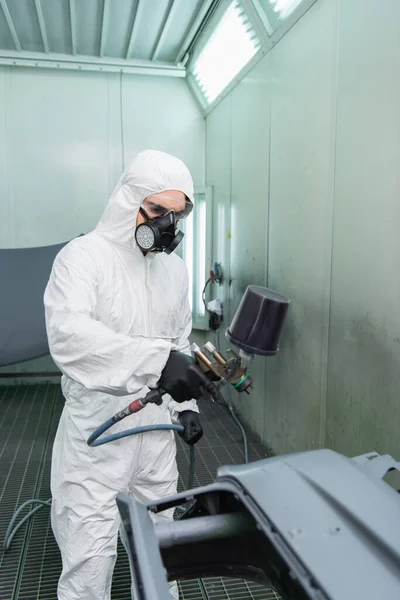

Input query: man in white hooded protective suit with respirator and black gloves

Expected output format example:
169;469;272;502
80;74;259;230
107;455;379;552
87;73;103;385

44;150;216;600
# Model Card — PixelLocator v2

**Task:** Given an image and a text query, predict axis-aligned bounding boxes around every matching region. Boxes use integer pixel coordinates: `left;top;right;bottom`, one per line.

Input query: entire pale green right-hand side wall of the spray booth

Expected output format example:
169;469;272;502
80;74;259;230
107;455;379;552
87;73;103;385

206;0;400;459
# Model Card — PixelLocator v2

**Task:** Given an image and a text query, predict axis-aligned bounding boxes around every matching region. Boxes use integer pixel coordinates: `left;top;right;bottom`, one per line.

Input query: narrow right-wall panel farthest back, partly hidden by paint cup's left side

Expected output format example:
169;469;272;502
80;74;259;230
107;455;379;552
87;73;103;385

227;56;271;436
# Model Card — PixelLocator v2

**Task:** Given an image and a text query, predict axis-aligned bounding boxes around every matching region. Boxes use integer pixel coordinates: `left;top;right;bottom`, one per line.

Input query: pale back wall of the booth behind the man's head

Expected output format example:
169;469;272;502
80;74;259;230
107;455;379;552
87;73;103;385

0;67;205;383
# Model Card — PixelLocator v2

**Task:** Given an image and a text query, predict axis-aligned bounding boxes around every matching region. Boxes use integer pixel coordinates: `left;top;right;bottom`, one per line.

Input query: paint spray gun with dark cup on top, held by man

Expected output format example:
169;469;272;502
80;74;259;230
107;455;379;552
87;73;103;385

191;285;290;394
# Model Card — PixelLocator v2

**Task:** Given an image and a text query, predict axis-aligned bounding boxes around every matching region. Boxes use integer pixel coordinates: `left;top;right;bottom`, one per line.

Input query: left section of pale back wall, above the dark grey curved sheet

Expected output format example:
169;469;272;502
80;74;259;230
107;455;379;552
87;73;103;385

0;68;121;248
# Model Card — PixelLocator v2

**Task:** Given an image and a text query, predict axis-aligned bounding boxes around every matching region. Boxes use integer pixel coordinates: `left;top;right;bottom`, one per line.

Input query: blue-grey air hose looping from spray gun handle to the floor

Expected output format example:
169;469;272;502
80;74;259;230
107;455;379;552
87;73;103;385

3;390;195;552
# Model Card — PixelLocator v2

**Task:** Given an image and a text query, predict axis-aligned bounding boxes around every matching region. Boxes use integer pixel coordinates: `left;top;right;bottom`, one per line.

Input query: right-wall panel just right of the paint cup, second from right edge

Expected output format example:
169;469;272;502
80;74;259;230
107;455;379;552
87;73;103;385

266;2;337;452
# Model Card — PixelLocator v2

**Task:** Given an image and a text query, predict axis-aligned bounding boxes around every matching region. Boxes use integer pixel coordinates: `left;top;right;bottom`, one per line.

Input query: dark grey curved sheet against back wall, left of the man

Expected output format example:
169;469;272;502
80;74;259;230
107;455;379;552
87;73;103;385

0;242;67;367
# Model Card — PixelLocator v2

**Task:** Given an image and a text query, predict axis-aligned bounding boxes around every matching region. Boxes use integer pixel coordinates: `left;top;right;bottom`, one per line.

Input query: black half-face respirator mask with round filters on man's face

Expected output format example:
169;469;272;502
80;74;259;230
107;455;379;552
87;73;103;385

135;208;184;254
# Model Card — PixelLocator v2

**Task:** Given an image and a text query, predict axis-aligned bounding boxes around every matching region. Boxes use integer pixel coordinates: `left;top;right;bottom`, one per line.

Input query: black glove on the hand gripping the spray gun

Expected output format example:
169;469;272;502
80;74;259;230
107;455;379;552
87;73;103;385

158;350;219;402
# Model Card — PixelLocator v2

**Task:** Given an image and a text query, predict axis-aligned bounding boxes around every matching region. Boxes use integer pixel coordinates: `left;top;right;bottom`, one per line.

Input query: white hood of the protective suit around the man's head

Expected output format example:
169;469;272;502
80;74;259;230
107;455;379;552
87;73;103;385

95;150;194;250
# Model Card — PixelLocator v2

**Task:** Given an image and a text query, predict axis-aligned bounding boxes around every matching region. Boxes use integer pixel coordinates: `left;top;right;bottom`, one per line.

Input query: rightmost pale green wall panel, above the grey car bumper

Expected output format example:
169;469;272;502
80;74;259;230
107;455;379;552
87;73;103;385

327;0;400;457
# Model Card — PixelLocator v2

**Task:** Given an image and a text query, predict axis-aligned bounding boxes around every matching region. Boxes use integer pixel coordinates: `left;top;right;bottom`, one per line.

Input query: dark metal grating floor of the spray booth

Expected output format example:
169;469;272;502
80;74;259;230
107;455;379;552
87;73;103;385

0;385;278;600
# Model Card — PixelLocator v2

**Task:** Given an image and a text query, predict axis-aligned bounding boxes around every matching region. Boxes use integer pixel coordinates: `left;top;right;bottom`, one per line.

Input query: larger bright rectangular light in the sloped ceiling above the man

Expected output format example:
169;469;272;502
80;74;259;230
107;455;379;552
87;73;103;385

192;0;260;104
